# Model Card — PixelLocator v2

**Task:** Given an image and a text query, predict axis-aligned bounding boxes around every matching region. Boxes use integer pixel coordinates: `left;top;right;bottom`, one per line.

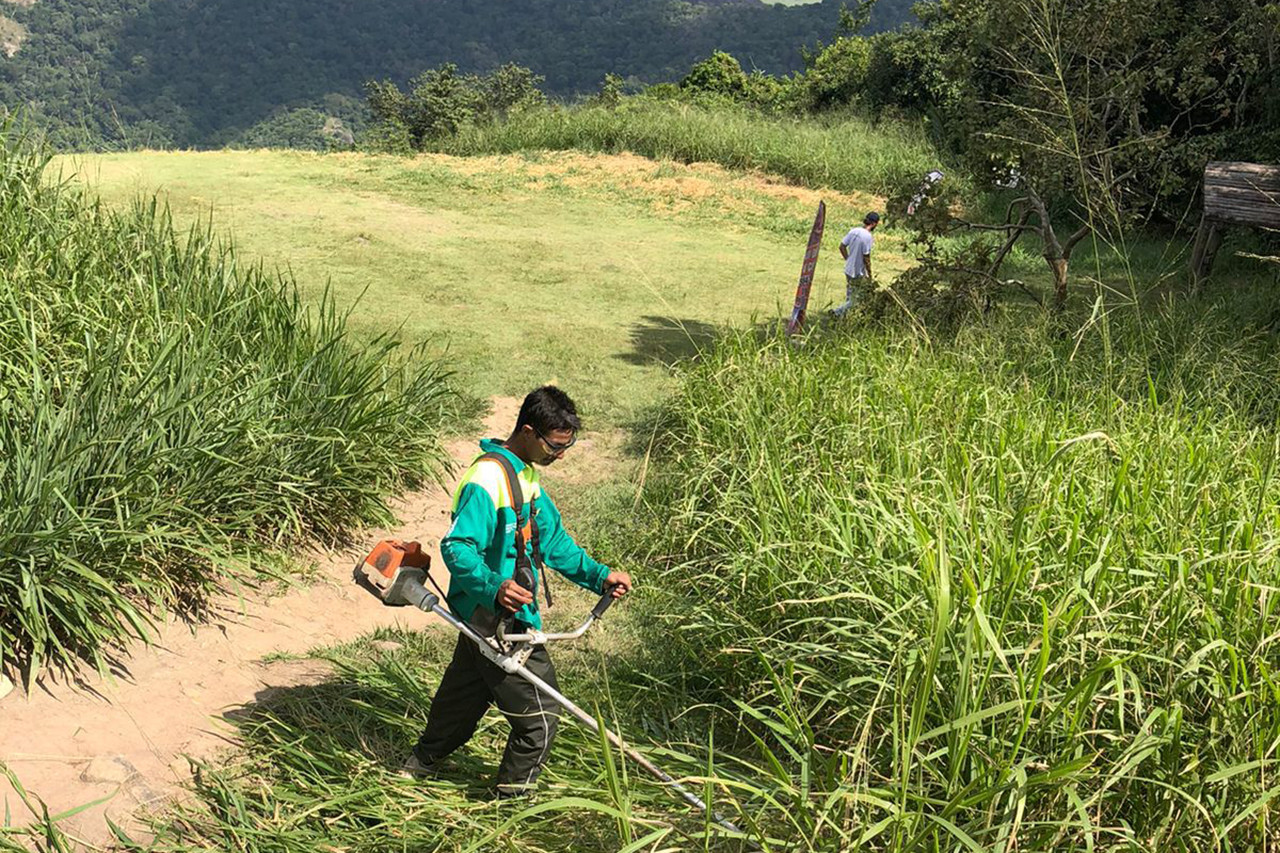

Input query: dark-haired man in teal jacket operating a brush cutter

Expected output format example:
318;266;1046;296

403;386;631;798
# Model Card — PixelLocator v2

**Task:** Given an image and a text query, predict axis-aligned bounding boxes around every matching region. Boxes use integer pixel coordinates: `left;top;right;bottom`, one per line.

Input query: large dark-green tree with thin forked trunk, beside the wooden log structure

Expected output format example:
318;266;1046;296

940;0;1280;305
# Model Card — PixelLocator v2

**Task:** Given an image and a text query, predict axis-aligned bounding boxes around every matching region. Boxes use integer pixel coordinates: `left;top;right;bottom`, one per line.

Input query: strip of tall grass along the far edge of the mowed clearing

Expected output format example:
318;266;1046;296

440;99;938;193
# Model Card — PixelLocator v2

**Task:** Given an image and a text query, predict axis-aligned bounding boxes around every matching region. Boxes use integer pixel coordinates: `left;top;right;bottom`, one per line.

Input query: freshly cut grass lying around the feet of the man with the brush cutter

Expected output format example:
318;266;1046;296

168;658;691;853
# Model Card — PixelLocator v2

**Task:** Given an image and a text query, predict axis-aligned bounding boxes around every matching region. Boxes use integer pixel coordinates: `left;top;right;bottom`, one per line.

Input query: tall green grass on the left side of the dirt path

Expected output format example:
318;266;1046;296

0;134;447;680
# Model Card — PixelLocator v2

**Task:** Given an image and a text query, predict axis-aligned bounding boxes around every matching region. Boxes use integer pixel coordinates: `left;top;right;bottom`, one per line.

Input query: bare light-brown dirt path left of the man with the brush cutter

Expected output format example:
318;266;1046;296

0;398;520;848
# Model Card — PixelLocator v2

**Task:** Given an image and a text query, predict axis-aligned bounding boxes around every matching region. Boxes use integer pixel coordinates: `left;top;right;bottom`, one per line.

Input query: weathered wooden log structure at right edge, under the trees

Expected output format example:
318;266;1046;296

1190;163;1280;288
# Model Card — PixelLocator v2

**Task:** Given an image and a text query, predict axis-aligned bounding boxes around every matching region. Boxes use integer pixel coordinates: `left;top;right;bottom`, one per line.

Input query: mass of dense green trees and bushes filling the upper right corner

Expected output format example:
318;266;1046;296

800;0;1280;234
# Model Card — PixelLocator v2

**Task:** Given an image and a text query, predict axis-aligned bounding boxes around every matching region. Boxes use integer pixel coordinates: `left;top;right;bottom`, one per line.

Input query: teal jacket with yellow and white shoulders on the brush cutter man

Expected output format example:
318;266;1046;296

440;438;609;629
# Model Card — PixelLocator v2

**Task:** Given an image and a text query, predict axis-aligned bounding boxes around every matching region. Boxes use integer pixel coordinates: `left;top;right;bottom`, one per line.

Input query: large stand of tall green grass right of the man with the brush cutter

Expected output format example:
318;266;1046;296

641;293;1280;852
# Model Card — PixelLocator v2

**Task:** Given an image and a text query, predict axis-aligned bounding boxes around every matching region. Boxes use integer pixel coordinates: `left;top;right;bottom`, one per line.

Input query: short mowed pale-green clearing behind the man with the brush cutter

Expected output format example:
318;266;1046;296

56;151;904;425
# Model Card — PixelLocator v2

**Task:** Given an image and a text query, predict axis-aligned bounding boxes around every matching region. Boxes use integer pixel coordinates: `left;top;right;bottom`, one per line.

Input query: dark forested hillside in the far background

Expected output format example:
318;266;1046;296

0;0;910;146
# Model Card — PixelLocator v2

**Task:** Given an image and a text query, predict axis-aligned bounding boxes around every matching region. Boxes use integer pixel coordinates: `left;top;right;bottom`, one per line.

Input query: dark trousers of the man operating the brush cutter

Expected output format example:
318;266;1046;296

413;634;559;794
